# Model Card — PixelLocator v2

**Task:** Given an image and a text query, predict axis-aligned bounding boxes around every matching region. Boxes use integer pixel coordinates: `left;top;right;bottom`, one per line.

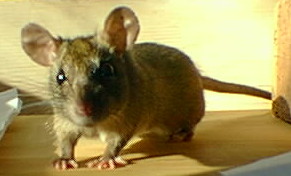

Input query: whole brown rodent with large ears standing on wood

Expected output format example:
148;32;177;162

21;7;271;170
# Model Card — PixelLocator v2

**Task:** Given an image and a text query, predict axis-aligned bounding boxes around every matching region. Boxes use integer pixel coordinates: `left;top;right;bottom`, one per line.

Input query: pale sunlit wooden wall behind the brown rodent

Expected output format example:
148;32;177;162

0;0;277;114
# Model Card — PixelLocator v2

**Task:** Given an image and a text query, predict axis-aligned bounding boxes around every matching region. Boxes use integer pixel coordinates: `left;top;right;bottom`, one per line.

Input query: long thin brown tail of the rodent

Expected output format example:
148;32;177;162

201;76;272;100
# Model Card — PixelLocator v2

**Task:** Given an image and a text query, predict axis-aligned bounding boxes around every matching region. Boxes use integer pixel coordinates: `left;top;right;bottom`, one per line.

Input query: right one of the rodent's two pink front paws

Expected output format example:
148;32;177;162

86;157;128;170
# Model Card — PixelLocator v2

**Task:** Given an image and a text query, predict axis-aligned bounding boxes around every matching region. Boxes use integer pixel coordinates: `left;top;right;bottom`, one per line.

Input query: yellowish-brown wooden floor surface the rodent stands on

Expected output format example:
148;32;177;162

0;110;291;176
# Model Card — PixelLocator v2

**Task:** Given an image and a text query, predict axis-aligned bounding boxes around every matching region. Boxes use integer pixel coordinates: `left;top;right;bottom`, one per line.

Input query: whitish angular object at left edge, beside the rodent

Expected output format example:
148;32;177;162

0;88;22;140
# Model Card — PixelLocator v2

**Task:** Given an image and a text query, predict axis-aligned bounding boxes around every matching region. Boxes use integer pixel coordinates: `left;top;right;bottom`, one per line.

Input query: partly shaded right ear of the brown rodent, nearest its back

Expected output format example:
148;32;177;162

102;7;139;54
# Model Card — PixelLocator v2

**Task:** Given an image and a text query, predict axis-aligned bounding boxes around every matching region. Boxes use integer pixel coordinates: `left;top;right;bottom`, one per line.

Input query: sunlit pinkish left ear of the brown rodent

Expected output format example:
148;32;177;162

21;23;60;66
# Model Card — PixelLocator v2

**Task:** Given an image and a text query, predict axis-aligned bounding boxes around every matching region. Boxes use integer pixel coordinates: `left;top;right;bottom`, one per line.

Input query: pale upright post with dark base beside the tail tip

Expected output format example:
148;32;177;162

272;0;291;123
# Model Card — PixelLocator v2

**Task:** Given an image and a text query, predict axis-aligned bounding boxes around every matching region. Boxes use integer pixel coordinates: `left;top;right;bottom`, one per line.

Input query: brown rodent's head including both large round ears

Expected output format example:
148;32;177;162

21;7;139;126
